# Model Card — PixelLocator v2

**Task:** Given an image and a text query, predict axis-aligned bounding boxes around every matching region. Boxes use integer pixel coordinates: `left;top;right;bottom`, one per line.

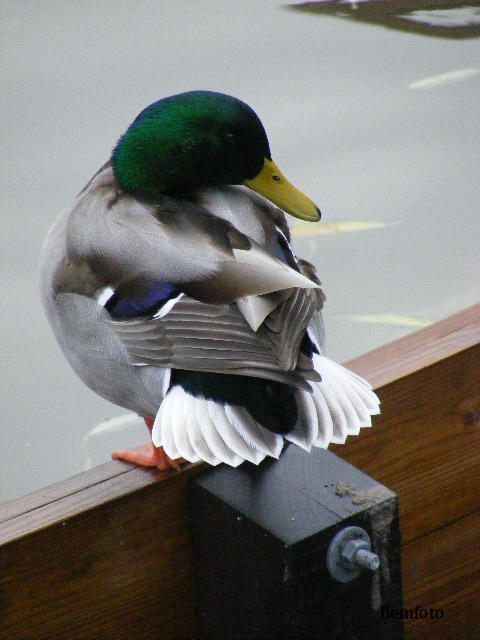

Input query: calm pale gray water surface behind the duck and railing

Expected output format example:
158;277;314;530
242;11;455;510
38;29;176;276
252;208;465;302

0;0;480;500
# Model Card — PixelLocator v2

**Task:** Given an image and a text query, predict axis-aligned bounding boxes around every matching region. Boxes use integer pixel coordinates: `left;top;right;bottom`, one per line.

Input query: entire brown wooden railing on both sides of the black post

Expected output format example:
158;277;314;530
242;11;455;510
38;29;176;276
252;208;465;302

0;305;480;640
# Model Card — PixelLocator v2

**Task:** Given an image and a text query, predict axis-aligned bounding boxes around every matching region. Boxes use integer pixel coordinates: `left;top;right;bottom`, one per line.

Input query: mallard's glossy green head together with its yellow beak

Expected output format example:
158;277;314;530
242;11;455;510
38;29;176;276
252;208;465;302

112;91;320;221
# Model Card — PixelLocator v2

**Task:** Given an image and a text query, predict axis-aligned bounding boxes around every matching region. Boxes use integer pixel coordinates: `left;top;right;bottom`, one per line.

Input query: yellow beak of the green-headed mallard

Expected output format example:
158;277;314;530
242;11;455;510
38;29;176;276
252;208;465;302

243;158;320;222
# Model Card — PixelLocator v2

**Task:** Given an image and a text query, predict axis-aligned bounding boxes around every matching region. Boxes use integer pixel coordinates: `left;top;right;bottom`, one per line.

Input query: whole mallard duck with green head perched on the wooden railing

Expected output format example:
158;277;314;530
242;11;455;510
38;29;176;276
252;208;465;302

40;91;379;469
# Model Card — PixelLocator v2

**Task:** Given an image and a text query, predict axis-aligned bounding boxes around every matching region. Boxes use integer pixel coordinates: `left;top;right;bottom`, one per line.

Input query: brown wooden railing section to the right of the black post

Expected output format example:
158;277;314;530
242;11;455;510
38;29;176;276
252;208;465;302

338;304;480;640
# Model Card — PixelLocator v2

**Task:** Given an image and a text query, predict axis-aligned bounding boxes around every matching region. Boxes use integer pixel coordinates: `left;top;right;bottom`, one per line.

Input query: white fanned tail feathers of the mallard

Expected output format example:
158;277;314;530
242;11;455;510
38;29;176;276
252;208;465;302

152;354;380;467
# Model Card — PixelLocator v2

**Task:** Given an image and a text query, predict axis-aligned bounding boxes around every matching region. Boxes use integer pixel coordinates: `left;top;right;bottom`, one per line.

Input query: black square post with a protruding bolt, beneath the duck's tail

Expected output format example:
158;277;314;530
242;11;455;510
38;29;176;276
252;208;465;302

190;447;404;640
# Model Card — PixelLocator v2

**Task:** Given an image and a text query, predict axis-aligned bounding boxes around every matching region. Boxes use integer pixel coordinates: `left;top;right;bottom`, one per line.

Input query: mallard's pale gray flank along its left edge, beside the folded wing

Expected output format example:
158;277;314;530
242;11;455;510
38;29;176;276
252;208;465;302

39;166;169;415
